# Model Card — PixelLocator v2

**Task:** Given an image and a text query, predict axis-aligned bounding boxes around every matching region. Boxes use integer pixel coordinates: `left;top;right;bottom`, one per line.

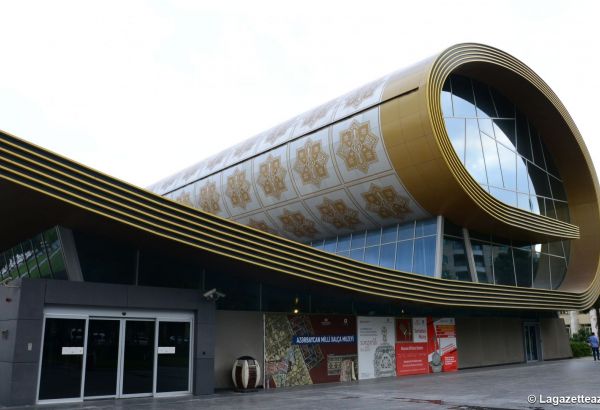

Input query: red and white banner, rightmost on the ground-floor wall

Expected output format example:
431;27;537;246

396;317;458;376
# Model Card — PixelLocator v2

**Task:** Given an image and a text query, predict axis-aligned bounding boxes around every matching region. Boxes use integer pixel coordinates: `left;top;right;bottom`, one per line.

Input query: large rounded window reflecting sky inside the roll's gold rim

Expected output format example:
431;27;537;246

442;75;569;221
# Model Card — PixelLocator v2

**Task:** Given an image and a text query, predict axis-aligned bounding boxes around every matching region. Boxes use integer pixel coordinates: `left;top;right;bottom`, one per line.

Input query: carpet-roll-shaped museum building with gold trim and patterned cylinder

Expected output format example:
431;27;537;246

0;44;600;405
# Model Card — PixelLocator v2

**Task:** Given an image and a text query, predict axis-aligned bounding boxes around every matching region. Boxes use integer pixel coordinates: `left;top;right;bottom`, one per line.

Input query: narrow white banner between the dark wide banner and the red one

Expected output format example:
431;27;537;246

357;316;396;380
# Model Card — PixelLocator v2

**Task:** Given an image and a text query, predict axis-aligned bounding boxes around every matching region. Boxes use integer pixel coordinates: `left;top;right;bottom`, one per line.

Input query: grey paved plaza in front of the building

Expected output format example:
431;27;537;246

5;358;600;410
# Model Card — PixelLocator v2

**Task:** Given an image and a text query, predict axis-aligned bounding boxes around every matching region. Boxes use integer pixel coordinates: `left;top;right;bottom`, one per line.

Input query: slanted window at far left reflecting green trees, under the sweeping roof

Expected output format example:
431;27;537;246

0;228;67;283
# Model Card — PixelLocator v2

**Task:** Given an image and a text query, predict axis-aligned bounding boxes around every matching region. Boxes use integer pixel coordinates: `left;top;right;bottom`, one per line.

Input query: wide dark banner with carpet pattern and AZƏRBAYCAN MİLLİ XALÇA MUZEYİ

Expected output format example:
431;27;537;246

265;313;358;388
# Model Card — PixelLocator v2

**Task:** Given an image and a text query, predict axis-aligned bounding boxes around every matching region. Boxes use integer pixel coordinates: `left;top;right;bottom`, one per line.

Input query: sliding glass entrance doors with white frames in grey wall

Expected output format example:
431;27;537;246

38;309;193;403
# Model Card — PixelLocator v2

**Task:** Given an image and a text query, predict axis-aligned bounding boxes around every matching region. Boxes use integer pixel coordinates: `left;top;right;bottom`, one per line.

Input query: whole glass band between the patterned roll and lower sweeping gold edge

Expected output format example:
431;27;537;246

310;218;570;289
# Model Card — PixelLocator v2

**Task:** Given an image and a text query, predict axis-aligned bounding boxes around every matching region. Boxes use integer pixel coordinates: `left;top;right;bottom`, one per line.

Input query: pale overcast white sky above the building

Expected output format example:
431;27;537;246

0;0;600;187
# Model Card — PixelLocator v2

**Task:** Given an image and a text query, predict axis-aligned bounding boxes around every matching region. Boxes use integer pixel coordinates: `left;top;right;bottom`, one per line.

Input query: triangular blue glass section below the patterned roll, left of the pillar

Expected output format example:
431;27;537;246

311;218;437;276
